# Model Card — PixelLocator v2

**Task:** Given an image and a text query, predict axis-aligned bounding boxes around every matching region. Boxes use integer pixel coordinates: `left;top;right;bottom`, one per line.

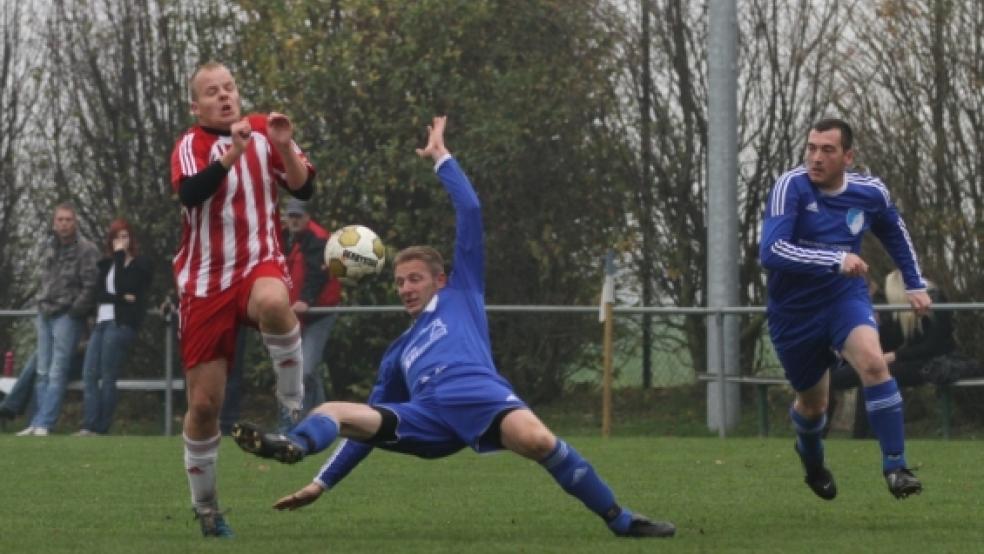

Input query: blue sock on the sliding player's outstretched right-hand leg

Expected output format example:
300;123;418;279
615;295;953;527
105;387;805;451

540;438;632;533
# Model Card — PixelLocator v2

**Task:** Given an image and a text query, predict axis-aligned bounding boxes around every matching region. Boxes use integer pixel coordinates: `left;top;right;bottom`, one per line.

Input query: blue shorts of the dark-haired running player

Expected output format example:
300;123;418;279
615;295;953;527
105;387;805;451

768;296;878;391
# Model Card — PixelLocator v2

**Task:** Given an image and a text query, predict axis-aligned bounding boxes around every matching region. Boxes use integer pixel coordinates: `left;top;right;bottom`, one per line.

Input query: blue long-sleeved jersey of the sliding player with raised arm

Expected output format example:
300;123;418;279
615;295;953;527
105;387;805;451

315;157;497;488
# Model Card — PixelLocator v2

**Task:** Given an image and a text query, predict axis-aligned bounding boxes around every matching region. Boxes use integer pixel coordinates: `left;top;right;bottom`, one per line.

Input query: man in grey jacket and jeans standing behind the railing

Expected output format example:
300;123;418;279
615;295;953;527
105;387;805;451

17;202;99;437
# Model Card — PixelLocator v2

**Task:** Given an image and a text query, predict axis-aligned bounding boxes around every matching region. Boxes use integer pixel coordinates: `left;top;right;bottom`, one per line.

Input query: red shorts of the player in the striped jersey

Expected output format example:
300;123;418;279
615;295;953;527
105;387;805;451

178;261;290;371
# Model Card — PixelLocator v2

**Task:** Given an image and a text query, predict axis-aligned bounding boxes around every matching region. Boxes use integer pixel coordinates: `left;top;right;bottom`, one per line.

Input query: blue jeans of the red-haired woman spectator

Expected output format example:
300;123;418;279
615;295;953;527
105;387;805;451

82;321;137;433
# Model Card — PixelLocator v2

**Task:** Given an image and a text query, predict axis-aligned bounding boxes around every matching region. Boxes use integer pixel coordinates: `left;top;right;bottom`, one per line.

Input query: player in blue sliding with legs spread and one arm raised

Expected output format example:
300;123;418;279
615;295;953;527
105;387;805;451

233;117;676;537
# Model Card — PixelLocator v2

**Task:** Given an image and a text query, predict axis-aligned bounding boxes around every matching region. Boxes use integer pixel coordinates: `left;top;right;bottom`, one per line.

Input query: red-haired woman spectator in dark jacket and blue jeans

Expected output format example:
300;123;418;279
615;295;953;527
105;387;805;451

76;219;153;436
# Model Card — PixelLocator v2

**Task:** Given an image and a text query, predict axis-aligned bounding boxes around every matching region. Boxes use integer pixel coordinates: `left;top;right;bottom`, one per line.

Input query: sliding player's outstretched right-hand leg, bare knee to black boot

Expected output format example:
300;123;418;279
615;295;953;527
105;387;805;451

499;408;676;537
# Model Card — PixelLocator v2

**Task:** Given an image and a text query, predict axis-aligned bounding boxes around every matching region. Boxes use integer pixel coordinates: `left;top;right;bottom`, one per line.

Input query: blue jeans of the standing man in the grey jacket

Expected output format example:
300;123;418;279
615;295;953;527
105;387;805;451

31;314;83;429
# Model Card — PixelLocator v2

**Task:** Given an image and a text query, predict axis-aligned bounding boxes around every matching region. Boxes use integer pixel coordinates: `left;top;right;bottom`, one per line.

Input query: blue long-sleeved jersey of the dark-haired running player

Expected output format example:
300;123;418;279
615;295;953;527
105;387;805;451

759;166;926;311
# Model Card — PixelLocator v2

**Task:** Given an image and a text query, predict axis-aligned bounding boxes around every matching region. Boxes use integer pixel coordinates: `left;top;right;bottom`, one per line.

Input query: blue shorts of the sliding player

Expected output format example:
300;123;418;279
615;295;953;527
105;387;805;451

376;369;527;457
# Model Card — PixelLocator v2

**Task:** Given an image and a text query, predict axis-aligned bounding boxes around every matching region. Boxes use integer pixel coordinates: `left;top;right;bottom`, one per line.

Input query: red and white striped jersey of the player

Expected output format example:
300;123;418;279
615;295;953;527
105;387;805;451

171;114;314;297
